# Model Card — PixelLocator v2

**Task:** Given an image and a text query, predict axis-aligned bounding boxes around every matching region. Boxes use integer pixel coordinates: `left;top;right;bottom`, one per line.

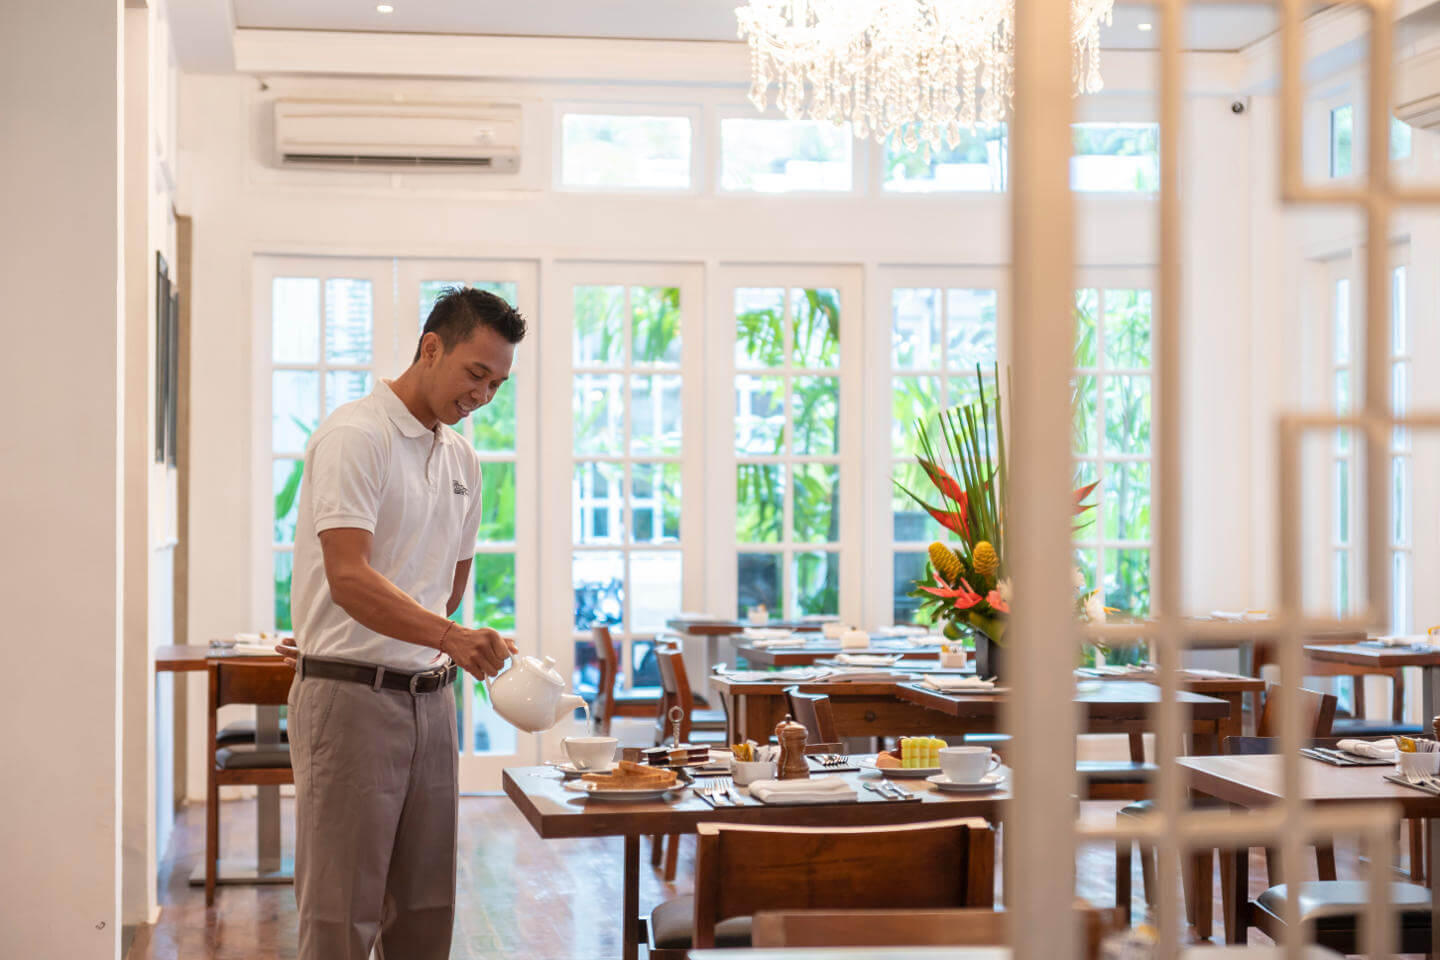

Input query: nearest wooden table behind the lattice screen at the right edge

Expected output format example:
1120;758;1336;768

1175;754;1440;956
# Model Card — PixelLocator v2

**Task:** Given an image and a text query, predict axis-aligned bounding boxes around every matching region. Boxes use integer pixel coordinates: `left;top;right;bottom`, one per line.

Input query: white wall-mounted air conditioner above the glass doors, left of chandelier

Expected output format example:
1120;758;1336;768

275;99;520;173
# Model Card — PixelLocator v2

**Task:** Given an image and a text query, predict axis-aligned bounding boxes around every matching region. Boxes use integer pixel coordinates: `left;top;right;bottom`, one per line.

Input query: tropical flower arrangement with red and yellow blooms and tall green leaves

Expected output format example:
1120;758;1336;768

896;367;1104;656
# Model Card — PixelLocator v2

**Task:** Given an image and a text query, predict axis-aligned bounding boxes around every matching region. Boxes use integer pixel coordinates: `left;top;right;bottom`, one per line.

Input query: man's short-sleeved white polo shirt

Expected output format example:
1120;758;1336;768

291;381;481;672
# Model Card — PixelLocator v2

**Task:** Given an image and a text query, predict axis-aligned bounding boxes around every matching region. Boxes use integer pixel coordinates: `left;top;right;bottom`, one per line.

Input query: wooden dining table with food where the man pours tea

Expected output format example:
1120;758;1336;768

503;767;1009;960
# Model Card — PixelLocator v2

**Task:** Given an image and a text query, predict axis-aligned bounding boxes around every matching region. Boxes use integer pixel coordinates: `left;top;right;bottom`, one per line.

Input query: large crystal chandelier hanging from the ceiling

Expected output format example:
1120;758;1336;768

734;0;1115;155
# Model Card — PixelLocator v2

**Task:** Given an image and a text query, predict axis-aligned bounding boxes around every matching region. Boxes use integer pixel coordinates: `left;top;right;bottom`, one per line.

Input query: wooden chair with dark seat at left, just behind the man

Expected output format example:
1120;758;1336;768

204;659;295;907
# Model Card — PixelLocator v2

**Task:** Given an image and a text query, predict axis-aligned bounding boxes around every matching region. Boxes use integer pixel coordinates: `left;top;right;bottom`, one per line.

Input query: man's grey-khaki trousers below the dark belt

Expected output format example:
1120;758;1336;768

288;674;459;960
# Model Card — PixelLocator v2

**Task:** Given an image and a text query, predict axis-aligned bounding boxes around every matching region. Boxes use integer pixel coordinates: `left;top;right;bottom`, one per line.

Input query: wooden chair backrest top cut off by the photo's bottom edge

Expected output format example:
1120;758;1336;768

750;904;1117;960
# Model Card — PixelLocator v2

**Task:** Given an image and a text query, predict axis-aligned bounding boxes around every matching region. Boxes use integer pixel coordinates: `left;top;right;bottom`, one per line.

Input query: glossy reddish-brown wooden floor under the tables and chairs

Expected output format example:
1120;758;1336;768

127;796;1356;960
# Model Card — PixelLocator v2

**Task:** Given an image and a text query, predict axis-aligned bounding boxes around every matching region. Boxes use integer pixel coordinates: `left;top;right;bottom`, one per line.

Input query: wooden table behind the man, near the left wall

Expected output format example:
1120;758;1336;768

156;638;295;887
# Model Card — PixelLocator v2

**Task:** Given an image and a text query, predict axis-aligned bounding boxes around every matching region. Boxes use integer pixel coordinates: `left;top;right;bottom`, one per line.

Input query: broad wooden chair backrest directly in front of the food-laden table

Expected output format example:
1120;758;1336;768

694;818;995;948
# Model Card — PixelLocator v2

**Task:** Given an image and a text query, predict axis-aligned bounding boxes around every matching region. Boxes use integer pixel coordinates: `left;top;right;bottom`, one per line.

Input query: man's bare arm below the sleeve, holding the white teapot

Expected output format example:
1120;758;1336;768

320;527;517;676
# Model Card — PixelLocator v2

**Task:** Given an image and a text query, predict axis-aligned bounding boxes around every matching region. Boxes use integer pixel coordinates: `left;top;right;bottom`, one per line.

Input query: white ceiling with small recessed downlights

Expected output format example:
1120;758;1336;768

233;0;1277;50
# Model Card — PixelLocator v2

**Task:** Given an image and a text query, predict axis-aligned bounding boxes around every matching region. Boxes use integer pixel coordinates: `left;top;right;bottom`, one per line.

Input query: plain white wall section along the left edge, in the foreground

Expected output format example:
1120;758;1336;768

0;0;124;959
